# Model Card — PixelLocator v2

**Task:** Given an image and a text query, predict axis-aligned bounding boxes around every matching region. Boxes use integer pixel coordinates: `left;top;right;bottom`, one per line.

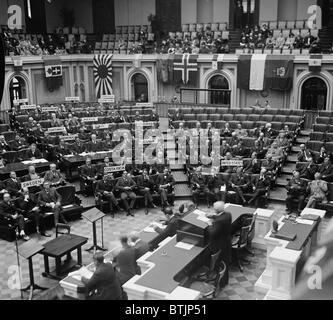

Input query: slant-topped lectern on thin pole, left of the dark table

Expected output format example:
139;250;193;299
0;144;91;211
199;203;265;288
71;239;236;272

18;240;47;300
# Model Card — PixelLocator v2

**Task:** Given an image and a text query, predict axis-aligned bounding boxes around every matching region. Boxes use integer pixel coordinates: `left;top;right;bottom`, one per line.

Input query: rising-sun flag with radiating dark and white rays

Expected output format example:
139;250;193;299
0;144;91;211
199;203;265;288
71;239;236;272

94;54;113;98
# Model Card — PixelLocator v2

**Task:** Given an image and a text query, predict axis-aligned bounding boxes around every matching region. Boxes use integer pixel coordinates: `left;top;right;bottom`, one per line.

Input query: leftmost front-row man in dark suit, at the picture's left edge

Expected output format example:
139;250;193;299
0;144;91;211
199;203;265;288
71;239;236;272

0;192;29;241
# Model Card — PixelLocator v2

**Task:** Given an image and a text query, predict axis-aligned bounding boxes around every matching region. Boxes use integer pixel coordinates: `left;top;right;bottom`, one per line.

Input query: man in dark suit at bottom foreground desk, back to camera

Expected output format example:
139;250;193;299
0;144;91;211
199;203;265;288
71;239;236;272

81;252;122;300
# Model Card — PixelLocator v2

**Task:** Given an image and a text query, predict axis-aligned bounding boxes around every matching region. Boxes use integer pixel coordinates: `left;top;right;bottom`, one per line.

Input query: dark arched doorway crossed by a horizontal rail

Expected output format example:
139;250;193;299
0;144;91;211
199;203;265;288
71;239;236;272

208;74;230;105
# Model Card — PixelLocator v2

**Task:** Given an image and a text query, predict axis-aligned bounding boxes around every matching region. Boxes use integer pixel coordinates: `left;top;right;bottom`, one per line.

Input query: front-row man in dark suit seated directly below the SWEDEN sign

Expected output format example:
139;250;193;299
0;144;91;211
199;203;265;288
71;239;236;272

17;188;50;237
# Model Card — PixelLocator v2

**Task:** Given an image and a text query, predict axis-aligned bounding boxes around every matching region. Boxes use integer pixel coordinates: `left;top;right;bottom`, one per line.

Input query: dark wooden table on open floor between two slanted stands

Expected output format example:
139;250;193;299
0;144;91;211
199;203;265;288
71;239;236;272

42;234;88;279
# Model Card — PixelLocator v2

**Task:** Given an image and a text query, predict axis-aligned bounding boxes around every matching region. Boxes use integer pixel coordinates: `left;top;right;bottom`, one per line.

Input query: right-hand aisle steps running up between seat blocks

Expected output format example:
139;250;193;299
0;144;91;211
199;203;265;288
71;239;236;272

269;129;311;202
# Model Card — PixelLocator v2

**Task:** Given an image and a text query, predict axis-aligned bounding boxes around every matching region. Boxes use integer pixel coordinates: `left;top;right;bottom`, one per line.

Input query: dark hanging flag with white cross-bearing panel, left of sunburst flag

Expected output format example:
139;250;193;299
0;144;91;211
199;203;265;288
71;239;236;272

43;56;62;91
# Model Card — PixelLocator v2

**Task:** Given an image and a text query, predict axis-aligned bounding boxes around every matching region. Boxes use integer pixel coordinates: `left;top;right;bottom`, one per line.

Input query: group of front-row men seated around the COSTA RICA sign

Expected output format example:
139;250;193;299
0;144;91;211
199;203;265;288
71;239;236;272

80;157;175;216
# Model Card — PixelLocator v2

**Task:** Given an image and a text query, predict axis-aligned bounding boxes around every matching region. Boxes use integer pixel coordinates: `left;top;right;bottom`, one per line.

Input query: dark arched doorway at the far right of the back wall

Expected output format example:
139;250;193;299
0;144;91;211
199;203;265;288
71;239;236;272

301;77;327;110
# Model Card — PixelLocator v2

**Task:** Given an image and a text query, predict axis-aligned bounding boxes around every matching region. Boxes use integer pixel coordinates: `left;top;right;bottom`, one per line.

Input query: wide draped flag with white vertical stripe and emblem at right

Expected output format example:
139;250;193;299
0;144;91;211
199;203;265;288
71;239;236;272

237;54;294;91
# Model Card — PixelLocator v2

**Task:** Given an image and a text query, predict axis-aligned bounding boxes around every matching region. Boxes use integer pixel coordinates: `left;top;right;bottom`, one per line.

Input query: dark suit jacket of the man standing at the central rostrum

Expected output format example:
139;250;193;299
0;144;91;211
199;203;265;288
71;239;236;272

209;211;232;265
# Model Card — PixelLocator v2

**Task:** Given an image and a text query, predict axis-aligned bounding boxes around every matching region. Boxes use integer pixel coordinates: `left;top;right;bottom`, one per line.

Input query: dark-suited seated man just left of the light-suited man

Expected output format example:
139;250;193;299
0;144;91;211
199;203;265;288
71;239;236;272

286;171;307;214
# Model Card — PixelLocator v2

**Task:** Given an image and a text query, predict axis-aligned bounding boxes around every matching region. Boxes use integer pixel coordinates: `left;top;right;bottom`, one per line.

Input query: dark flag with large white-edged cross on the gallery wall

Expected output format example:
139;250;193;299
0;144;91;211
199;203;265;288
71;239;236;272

173;53;198;84
